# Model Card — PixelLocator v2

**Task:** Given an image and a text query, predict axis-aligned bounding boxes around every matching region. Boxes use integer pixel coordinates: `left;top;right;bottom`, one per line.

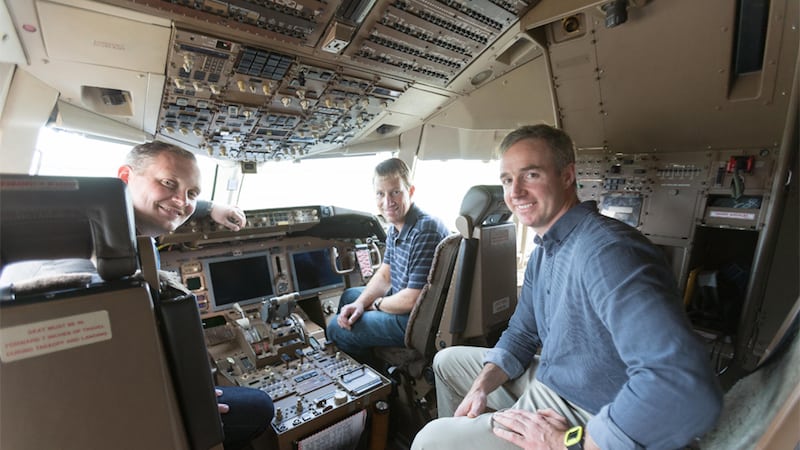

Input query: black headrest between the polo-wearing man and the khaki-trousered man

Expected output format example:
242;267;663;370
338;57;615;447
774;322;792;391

456;185;511;238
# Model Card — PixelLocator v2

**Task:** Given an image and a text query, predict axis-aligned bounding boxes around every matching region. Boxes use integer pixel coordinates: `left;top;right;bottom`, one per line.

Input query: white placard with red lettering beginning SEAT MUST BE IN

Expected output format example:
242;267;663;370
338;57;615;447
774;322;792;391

0;310;111;363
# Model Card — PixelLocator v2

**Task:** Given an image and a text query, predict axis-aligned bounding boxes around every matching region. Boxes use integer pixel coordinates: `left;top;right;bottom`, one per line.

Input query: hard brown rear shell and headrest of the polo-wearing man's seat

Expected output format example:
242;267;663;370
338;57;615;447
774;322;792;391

449;185;517;345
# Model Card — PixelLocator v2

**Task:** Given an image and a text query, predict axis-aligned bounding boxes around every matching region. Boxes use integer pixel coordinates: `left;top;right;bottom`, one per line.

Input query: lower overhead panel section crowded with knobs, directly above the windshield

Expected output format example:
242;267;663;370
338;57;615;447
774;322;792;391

158;30;402;162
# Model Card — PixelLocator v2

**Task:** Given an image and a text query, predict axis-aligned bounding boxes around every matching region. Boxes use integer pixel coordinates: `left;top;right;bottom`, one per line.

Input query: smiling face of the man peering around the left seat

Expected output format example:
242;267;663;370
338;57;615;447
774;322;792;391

118;152;200;236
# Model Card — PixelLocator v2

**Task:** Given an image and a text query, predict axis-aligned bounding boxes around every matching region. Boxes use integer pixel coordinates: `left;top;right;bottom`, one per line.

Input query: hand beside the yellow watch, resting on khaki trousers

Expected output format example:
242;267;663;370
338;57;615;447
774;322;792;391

492;409;569;450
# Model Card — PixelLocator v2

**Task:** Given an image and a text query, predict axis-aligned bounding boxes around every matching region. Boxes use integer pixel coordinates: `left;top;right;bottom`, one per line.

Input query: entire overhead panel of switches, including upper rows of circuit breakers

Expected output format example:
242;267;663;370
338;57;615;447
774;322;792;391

97;0;536;162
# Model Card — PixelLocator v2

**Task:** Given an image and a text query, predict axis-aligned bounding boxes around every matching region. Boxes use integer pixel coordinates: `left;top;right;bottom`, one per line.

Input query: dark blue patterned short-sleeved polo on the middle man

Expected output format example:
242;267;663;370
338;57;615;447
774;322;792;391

383;203;450;295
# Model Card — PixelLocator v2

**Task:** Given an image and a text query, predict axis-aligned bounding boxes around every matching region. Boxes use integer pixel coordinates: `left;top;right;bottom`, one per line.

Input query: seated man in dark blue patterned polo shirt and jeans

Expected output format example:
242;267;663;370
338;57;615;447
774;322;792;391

327;158;450;360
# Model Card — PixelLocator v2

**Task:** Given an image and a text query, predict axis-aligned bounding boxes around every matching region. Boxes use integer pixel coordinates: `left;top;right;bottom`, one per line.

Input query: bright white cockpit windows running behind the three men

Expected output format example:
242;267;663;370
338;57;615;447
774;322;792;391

36;128;506;231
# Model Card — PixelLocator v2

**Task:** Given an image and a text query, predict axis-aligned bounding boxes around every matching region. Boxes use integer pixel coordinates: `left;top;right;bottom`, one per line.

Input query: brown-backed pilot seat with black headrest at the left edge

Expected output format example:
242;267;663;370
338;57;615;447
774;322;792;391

0;175;222;450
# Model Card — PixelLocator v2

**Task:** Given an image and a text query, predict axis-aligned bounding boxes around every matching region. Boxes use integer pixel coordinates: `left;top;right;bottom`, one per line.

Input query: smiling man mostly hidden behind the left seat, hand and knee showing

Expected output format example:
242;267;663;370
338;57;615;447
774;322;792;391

117;141;274;450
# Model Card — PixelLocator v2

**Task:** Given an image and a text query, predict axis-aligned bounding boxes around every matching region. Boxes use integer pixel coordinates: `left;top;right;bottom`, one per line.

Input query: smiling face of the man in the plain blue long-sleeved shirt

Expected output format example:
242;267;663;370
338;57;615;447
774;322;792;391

500;138;578;236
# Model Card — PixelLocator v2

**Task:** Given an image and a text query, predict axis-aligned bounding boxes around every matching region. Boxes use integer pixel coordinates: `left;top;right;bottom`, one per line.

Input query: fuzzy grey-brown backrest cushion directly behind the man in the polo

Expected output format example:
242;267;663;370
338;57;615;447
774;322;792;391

405;234;461;358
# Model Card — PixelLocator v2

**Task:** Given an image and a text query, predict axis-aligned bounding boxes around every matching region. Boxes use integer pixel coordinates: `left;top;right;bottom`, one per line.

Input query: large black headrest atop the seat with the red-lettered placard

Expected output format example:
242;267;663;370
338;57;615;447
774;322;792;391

0;174;138;281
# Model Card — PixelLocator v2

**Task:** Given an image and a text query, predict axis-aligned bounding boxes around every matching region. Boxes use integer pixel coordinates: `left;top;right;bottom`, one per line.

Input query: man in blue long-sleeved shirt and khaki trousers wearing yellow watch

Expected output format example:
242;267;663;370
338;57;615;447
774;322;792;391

412;125;722;450
